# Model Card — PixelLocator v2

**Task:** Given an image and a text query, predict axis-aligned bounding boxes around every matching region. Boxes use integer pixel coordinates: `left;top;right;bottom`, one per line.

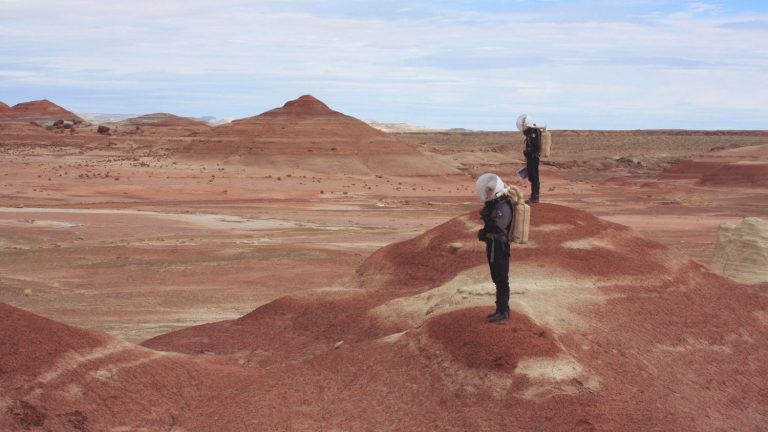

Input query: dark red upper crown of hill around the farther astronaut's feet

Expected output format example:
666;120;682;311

356;203;666;295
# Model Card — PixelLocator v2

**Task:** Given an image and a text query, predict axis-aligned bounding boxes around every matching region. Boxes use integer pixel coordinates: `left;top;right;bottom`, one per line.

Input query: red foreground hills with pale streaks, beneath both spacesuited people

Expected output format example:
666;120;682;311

0;204;768;431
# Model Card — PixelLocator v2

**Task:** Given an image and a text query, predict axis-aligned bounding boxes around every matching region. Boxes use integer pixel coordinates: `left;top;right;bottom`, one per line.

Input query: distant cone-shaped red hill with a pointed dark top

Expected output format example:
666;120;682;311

180;95;455;175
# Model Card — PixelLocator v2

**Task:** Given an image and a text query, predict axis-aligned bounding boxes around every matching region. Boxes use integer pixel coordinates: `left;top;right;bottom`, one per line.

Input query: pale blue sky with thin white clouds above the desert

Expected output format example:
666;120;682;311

0;0;768;130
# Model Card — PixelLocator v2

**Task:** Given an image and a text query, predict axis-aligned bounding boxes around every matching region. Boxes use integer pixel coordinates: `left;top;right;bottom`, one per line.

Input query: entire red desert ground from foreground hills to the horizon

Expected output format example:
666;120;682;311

0;95;768;432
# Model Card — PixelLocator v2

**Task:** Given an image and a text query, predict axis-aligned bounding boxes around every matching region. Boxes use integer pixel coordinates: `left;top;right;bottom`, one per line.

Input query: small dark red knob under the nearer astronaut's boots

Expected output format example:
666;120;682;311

426;308;561;373
